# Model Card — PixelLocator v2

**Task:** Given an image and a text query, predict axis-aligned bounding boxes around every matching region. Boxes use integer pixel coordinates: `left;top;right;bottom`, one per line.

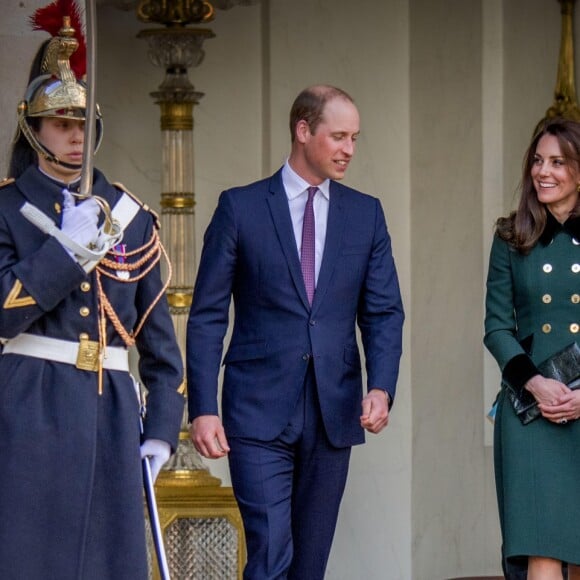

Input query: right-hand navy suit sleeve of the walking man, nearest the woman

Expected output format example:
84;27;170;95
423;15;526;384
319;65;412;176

358;200;404;402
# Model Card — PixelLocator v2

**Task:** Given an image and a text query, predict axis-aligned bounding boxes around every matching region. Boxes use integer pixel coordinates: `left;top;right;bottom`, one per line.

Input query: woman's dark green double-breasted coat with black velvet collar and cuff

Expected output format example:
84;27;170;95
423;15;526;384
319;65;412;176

484;216;580;564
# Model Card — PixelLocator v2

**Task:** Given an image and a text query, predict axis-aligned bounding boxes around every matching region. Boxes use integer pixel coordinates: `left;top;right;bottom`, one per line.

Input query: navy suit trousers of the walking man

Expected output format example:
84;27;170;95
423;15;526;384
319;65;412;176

229;366;350;580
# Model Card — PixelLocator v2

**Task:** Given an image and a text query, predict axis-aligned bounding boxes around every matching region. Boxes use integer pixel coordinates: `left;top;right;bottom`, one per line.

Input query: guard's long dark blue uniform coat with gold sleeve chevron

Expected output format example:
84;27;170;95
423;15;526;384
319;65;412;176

0;167;184;580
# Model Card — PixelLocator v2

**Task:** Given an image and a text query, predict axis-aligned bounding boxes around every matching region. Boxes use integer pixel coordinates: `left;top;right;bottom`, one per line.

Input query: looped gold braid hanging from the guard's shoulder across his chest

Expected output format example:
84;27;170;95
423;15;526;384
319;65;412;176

95;190;172;394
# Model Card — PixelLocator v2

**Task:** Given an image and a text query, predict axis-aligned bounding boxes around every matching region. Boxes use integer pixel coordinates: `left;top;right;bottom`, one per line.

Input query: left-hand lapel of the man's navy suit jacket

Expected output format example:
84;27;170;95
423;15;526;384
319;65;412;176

268;170;310;309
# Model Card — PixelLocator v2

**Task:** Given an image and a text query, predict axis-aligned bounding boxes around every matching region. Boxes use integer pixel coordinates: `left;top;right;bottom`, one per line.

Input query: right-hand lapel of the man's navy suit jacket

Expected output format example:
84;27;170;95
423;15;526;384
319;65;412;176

312;181;345;311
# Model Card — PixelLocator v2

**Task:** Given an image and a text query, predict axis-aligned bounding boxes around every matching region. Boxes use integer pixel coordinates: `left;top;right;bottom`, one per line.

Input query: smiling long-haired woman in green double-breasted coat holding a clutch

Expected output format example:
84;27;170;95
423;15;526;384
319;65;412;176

484;119;580;580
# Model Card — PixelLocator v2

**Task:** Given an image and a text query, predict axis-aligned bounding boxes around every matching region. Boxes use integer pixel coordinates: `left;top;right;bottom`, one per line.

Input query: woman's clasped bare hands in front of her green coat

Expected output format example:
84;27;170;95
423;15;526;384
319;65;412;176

525;375;580;424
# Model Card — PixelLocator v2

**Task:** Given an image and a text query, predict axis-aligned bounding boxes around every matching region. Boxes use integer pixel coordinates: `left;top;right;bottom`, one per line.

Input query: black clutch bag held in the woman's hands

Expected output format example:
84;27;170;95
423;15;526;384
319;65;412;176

502;342;580;425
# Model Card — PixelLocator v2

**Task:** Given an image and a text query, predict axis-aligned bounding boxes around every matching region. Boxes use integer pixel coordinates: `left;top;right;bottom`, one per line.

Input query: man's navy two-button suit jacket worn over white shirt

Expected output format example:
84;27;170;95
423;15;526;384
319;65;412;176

186;171;404;447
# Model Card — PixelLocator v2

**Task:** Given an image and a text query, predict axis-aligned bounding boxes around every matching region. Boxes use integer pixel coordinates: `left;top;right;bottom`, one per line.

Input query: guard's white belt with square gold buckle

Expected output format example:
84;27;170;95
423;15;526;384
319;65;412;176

2;333;129;372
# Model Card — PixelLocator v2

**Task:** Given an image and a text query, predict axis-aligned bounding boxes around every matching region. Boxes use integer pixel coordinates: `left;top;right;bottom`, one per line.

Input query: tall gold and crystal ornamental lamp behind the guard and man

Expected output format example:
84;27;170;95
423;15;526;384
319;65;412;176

136;0;257;580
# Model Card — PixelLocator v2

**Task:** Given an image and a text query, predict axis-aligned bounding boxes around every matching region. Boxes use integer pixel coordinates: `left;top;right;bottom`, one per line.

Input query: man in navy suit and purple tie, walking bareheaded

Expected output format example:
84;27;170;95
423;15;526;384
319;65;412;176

187;85;404;580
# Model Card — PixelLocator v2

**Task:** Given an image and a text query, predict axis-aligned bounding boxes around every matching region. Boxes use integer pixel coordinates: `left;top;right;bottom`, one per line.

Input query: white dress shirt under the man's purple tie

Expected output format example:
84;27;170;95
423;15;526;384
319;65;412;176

282;160;330;282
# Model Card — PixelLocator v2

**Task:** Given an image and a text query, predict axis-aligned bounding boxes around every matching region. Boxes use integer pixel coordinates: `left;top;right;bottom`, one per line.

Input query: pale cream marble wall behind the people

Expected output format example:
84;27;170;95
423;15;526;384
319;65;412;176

0;0;572;580
